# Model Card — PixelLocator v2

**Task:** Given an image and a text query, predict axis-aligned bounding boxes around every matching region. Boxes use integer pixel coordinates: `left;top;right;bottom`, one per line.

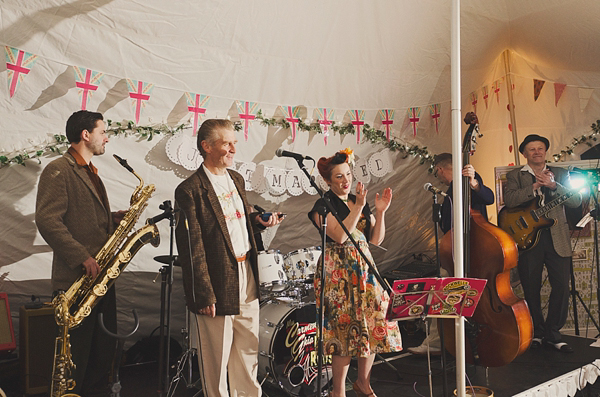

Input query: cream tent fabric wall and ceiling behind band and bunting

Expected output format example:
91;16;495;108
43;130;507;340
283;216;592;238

0;0;600;344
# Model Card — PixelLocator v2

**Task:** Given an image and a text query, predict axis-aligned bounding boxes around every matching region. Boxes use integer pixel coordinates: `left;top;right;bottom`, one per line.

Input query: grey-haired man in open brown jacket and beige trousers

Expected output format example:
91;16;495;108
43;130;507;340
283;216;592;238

175;119;281;397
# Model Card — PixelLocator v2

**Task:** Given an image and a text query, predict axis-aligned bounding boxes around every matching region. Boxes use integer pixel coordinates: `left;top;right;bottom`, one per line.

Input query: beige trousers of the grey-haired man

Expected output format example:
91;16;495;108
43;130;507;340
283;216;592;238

192;260;261;397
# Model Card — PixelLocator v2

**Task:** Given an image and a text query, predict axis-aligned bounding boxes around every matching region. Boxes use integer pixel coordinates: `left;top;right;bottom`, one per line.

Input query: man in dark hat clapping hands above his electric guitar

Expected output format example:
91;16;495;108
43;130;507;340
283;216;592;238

504;134;581;353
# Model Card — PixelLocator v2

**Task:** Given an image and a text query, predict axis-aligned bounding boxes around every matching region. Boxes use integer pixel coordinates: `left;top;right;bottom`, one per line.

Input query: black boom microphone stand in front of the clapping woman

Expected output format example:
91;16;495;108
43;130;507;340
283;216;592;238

294;157;395;396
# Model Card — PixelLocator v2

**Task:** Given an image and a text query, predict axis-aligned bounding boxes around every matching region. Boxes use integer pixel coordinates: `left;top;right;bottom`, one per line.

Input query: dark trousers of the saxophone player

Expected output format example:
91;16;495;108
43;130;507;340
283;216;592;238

69;287;117;395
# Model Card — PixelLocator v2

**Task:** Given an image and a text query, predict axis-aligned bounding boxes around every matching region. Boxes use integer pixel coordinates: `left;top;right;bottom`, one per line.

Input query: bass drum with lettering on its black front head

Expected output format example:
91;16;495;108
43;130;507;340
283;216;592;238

258;300;332;396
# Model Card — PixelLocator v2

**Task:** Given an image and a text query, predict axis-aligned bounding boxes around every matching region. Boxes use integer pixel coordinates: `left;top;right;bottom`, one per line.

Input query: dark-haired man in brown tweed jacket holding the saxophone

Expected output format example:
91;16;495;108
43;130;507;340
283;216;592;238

35;110;124;396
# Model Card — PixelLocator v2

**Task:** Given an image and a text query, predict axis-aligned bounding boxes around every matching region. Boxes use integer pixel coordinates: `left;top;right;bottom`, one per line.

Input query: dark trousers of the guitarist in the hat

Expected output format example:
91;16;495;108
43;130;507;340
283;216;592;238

518;229;570;342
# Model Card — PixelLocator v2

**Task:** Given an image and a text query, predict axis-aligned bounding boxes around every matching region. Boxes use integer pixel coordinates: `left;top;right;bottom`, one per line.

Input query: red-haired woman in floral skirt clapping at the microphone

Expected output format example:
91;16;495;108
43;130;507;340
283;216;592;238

308;149;402;397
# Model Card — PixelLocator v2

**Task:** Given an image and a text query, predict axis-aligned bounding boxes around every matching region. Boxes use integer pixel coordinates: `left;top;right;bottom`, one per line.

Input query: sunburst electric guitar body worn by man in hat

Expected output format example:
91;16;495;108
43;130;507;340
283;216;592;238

498;197;556;250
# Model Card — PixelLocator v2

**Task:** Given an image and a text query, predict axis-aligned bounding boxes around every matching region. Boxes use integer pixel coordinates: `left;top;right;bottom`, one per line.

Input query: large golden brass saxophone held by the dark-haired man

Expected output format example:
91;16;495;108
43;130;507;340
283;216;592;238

50;155;160;397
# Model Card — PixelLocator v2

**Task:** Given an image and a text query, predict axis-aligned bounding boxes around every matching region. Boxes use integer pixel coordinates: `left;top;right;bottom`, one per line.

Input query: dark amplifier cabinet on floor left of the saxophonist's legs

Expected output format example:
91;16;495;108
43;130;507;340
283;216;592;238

19;306;58;394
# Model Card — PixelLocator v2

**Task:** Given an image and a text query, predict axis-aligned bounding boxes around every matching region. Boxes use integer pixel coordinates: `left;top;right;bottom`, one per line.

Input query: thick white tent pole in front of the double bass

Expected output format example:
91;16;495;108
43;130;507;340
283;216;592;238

450;0;466;397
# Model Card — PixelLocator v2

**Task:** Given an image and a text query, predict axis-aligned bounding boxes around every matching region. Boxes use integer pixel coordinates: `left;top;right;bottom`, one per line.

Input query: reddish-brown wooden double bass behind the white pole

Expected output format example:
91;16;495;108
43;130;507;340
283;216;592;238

440;112;533;367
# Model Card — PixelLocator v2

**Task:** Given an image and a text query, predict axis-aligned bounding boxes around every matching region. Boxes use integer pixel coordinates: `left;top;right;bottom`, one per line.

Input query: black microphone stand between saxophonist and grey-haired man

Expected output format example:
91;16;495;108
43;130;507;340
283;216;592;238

152;200;175;397
